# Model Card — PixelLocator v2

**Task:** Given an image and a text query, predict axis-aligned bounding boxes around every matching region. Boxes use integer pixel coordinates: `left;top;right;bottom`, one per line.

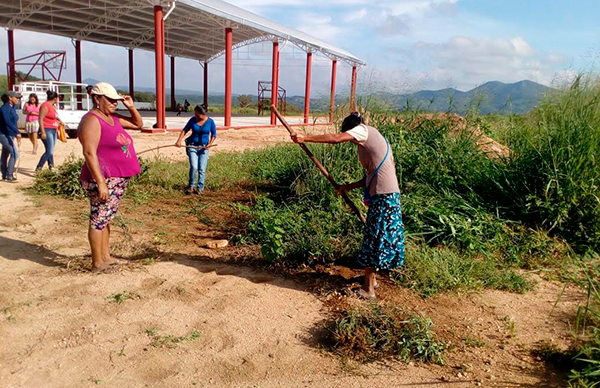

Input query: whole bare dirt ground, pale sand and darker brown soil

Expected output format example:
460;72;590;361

0;129;584;388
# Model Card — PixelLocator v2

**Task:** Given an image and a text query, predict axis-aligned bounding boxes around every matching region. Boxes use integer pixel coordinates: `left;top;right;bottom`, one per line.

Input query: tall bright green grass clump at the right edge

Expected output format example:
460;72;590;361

498;76;600;252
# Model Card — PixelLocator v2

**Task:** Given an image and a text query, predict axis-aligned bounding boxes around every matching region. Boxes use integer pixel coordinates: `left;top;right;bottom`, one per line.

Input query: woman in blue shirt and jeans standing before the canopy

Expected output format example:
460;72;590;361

175;104;217;194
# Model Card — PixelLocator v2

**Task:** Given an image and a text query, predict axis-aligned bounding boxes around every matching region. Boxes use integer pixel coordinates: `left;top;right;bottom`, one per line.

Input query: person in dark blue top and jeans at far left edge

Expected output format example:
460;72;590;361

0;91;21;182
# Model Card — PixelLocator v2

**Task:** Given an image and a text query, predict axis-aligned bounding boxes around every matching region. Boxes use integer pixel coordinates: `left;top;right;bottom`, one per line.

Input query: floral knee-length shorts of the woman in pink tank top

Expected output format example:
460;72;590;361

81;178;129;230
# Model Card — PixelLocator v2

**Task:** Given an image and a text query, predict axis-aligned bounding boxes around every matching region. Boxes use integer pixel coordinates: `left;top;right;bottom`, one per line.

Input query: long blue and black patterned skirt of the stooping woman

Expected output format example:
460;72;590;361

358;193;404;270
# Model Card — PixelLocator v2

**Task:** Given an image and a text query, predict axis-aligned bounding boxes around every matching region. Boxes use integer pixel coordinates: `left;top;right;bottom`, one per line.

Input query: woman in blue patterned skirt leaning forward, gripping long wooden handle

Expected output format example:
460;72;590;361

291;112;404;299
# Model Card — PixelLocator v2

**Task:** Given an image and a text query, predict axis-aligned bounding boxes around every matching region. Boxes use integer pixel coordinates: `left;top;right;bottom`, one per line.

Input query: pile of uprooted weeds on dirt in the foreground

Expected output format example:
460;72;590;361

329;304;446;365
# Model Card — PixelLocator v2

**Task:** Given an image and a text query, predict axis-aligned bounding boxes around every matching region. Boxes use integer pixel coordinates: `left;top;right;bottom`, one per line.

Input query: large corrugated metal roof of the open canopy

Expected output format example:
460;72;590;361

0;0;365;65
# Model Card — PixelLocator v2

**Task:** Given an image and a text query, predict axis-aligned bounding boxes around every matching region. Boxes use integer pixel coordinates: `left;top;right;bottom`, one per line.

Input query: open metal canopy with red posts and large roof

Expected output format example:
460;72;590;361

0;0;365;129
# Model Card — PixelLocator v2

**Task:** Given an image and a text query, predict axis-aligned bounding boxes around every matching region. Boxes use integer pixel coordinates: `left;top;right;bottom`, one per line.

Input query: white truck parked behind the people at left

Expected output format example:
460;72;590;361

14;81;93;137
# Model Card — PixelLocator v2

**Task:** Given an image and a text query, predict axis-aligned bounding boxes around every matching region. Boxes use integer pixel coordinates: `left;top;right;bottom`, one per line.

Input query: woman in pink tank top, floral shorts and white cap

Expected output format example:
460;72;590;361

78;82;143;272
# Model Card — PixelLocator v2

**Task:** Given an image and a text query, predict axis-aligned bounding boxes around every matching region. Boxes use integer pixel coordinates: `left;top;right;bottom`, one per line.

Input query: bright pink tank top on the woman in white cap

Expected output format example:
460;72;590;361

81;112;141;181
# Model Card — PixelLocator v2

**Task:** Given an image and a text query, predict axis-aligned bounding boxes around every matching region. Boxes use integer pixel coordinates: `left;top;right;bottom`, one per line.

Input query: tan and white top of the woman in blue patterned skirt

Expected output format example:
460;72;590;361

346;124;400;196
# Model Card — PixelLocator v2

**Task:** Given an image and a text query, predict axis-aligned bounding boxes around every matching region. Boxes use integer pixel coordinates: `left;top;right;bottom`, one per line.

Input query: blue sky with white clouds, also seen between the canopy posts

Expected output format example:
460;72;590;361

0;0;600;95
